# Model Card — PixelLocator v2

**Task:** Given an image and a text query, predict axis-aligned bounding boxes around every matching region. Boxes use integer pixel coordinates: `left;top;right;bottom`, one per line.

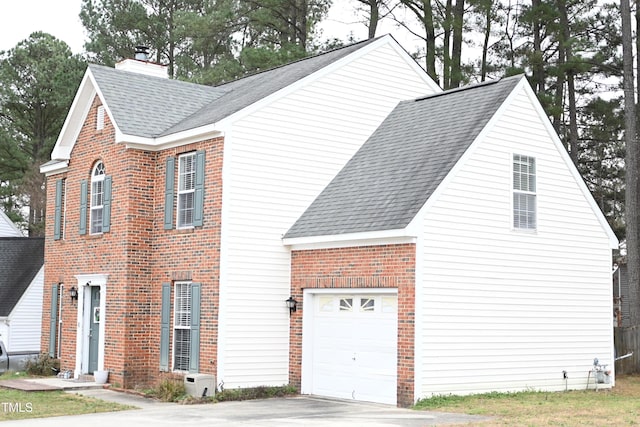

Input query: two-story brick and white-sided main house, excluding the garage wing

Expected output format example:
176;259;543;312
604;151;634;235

41;36;440;402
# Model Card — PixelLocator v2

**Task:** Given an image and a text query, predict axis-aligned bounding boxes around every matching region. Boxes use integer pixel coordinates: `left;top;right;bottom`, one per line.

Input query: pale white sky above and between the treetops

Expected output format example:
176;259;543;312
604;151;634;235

0;0;420;53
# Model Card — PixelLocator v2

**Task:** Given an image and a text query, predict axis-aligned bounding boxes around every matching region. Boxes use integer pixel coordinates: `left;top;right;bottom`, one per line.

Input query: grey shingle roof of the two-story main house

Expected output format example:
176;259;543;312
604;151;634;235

89;39;376;138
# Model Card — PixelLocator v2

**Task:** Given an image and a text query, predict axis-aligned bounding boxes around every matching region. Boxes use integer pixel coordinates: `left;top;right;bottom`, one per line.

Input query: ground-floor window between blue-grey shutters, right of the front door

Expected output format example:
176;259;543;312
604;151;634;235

173;282;191;371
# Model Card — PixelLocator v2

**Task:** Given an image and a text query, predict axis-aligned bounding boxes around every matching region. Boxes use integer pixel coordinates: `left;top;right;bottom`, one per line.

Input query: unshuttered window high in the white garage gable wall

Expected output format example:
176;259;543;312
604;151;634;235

513;154;537;230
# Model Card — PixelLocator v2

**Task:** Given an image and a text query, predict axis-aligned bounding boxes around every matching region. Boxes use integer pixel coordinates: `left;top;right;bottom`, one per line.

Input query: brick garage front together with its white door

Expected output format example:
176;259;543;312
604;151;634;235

289;243;416;406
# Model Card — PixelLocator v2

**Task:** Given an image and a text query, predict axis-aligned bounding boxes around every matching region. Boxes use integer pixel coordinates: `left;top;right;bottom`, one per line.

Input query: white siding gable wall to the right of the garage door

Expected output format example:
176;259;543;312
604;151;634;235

416;85;613;398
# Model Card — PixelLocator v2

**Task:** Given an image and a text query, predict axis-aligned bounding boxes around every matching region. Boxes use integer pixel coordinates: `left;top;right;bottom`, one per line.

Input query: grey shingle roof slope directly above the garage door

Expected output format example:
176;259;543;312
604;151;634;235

284;76;523;238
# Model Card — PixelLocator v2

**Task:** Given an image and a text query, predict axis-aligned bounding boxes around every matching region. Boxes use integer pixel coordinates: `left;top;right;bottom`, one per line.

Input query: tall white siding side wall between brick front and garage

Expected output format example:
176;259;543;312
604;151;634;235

218;44;433;387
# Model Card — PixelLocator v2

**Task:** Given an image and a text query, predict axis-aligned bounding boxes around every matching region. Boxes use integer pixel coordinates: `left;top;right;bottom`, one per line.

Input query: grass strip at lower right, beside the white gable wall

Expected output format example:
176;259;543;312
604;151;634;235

416;376;640;427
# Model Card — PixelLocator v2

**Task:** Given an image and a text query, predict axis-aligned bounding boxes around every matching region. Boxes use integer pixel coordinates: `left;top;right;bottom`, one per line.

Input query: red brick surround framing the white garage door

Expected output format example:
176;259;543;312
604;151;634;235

289;244;416;406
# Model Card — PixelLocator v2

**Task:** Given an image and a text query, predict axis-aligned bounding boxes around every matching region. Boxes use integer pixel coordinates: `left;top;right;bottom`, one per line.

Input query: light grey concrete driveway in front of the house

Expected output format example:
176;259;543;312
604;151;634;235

2;389;487;427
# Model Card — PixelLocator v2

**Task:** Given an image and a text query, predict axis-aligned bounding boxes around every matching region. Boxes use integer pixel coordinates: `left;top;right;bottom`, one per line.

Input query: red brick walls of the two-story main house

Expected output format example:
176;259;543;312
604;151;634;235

42;97;224;388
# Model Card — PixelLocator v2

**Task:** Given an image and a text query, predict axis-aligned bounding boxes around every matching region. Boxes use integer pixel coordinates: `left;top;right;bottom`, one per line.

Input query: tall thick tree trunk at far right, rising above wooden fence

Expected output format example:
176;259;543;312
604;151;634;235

620;0;640;326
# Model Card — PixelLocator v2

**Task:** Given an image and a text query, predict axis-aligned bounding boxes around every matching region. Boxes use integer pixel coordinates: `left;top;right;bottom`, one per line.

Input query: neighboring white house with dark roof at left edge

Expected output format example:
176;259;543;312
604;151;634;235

0;237;44;353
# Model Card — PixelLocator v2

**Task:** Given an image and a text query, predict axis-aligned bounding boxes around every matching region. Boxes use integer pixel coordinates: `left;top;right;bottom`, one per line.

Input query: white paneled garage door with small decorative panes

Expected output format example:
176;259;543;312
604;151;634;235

311;294;398;404
